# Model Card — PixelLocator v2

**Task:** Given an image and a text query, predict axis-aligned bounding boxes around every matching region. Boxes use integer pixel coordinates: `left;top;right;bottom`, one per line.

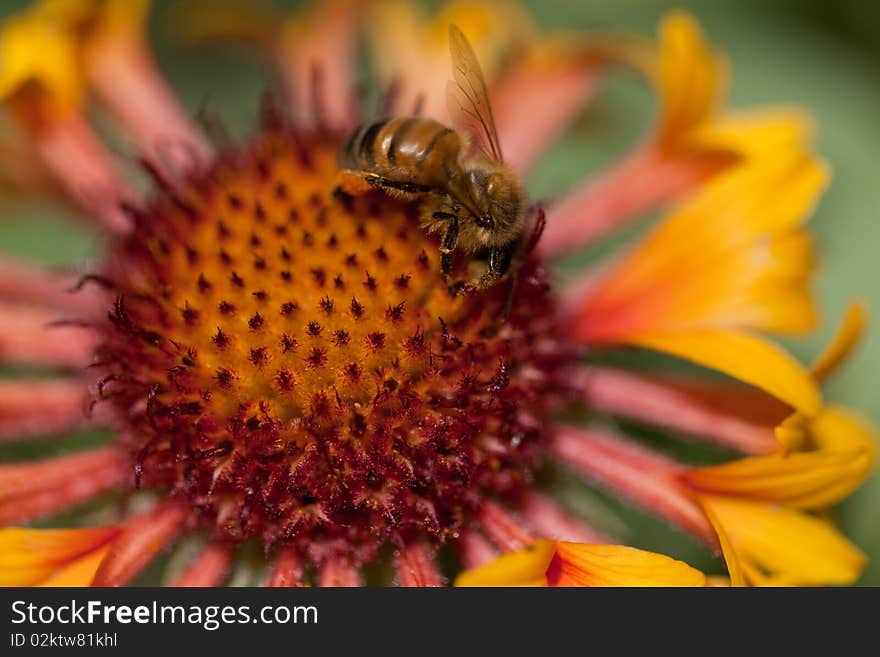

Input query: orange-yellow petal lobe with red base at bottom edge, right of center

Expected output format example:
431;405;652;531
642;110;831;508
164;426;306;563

547;542;706;586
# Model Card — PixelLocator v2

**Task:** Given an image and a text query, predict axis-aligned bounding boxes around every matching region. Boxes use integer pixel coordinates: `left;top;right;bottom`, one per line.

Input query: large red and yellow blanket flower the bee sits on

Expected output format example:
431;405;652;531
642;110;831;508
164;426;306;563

0;0;874;586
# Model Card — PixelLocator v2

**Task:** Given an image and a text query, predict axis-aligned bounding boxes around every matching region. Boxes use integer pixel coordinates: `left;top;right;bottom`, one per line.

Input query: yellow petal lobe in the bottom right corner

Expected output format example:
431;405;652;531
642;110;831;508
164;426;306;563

700;495;866;586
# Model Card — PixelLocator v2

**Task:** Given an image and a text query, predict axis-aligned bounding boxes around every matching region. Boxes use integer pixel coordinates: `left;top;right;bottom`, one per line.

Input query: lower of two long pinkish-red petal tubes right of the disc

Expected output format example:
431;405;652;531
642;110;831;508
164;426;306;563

550;425;717;546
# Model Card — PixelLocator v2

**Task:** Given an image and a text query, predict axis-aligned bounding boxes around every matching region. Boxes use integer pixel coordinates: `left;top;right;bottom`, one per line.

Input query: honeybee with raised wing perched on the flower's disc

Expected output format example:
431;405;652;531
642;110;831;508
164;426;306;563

339;25;529;289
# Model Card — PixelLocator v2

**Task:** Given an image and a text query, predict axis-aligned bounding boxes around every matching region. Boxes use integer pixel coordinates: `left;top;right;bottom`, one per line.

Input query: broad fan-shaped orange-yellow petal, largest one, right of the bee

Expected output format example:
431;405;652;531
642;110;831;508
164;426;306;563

570;152;827;343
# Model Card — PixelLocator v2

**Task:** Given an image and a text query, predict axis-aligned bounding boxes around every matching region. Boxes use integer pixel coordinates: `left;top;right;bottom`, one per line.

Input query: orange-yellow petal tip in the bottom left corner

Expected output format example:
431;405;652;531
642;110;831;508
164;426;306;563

0;527;119;586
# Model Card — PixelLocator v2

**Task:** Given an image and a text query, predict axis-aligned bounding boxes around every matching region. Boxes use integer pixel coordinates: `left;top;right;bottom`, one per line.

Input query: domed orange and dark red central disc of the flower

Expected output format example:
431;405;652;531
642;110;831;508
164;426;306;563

98;124;569;559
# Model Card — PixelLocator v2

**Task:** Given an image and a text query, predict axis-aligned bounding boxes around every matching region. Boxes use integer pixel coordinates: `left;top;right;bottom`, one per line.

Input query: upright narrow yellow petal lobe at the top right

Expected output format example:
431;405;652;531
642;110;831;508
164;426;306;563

657;11;727;143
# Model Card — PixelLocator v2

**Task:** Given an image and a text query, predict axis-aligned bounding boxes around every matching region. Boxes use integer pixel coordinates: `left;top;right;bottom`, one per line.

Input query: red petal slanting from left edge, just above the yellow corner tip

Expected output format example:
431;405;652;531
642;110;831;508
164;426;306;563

0;448;130;525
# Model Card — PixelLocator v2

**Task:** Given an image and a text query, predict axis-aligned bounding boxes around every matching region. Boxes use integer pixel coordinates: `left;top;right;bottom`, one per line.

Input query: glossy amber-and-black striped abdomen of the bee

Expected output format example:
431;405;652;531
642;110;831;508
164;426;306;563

339;117;461;188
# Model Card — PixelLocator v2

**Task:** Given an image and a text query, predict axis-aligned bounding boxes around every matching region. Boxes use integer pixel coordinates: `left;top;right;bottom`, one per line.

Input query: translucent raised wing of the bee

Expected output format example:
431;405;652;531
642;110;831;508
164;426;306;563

446;25;504;162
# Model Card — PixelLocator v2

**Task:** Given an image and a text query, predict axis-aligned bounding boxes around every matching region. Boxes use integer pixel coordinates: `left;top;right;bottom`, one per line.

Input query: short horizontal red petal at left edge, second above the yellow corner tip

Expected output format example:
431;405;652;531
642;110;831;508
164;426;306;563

0;379;89;443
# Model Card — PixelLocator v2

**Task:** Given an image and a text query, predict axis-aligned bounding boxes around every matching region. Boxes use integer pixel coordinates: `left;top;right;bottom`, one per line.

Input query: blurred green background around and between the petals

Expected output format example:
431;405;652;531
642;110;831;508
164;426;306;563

0;0;880;585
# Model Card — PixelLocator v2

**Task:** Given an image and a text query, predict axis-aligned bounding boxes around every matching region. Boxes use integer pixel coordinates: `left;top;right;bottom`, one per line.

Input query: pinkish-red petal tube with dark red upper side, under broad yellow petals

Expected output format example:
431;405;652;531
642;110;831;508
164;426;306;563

574;367;791;454
